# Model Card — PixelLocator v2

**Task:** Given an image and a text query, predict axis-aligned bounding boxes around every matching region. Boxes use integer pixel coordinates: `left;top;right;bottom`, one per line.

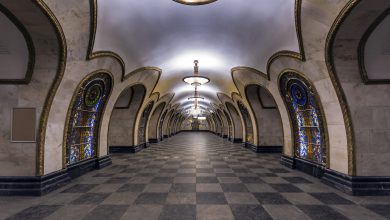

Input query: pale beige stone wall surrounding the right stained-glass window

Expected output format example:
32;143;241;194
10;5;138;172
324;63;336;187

233;0;350;174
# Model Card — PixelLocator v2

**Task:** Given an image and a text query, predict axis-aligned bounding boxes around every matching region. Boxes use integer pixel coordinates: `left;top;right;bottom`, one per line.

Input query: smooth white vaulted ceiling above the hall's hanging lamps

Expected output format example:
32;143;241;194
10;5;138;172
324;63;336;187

94;0;299;108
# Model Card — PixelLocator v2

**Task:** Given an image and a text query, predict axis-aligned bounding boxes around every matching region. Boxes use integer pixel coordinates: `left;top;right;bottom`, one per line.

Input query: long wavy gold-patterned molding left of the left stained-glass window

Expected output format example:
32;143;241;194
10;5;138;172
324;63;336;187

34;0;67;176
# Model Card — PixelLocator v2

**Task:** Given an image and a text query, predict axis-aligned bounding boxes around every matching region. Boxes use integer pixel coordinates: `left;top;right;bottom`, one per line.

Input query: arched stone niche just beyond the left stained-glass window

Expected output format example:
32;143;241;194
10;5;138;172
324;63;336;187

108;84;146;153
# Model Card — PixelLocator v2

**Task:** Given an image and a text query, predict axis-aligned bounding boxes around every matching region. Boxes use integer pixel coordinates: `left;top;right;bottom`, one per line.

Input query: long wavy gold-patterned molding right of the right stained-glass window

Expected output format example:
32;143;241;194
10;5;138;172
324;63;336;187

325;0;361;175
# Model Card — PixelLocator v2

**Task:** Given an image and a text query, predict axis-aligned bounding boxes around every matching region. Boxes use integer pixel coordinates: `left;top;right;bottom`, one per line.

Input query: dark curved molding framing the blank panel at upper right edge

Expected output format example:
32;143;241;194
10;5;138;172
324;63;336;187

358;8;390;85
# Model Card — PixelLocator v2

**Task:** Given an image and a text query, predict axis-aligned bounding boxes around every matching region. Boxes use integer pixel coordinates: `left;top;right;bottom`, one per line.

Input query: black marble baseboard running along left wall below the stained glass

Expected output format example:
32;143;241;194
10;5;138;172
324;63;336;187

0;155;112;196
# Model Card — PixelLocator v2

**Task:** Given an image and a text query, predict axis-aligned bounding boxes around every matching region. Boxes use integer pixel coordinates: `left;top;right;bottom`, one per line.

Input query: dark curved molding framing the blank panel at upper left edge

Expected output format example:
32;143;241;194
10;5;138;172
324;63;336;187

0;3;35;84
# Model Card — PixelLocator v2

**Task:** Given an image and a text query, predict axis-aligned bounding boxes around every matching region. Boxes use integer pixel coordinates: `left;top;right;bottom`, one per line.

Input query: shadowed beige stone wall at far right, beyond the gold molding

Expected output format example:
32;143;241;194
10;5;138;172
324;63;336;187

330;0;390;176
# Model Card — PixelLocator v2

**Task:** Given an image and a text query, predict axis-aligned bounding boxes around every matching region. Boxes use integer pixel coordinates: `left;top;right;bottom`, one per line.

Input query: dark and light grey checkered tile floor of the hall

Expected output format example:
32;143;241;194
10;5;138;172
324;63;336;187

0;133;390;220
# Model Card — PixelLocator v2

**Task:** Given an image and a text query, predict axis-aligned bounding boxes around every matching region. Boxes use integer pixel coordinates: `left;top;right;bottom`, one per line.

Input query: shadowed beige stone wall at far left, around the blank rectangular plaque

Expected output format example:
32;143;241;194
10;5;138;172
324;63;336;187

0;1;59;176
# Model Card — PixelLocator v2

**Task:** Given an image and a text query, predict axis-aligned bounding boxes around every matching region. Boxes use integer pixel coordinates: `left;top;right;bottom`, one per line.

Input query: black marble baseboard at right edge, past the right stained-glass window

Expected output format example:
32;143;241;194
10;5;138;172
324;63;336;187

321;169;390;196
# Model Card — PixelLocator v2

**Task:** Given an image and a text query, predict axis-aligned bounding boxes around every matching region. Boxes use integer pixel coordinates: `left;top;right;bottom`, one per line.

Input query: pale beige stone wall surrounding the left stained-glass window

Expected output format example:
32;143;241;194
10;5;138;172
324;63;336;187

40;0;160;174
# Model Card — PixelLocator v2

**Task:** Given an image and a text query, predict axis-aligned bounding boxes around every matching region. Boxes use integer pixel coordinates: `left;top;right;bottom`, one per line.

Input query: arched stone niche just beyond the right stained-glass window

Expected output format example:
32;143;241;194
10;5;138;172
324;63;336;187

245;84;284;152
